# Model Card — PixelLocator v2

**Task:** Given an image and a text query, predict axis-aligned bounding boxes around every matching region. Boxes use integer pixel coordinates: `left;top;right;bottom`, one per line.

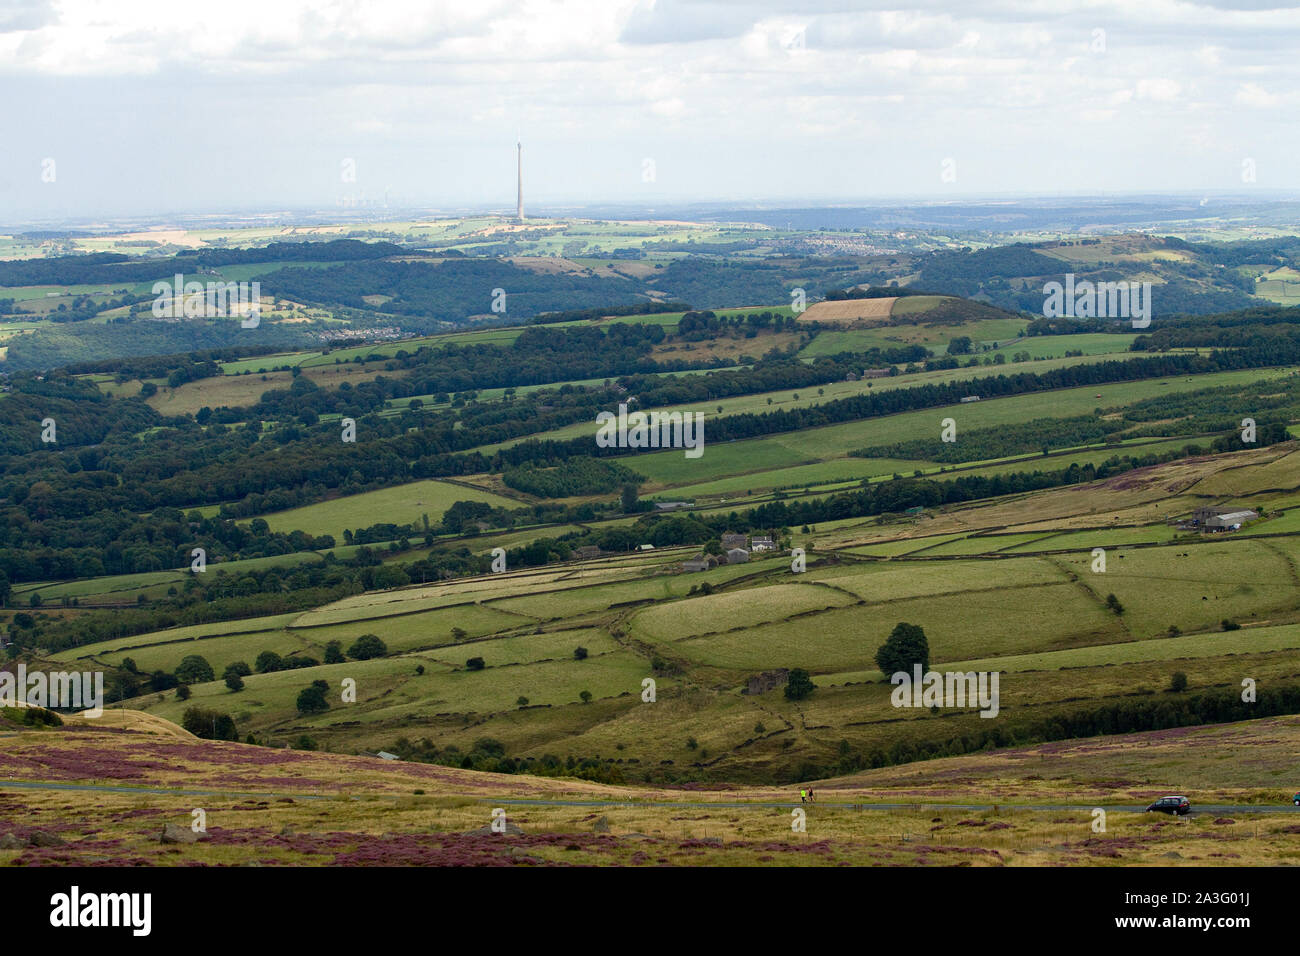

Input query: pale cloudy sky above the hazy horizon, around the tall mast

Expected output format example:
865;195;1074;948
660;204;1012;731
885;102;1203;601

0;0;1300;224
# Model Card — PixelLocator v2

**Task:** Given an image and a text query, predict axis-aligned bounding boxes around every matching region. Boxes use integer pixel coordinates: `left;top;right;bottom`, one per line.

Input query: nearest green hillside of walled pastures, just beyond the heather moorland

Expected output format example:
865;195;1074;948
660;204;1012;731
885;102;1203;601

55;447;1284;780
